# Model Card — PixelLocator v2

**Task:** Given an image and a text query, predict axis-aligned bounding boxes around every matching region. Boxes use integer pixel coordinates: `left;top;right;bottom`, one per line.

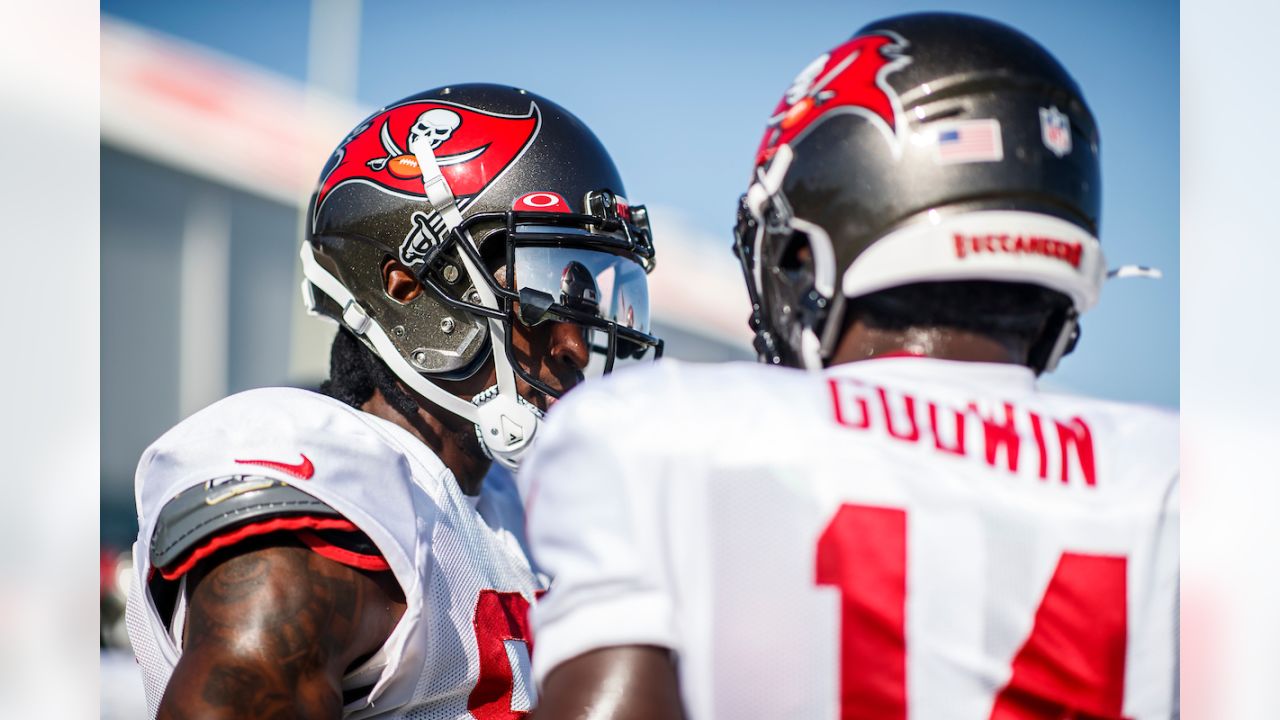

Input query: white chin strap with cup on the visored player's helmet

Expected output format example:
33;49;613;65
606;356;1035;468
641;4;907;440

301;143;541;470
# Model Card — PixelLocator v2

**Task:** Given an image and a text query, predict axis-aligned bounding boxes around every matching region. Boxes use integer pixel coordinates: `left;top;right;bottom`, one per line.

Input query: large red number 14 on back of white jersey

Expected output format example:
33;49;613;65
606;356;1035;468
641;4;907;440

815;505;1126;720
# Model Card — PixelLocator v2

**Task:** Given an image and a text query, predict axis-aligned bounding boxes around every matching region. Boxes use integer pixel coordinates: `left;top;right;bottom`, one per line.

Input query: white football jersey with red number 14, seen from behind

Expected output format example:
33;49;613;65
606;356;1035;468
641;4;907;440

518;357;1179;719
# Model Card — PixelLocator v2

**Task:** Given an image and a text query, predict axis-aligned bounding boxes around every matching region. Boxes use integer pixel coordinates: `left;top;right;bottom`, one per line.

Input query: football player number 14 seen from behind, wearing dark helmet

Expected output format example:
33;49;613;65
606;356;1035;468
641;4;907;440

517;14;1179;719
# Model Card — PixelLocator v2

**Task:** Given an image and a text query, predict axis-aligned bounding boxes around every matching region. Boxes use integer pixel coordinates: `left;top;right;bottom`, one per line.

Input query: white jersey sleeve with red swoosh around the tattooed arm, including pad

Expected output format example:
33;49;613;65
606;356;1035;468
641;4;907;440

128;388;453;712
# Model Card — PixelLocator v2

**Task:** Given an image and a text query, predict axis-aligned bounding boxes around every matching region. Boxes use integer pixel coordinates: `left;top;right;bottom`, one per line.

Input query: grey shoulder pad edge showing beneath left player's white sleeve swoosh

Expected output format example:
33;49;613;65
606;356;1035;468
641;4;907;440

151;475;342;568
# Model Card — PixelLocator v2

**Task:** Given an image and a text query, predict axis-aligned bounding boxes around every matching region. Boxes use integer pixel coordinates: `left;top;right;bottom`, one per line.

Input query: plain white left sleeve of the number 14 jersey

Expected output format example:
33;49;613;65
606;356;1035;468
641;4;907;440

518;370;691;684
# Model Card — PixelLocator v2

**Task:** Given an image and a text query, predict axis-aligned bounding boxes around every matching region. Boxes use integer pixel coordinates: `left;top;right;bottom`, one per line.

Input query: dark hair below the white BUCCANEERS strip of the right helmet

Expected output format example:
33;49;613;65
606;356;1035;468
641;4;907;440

845;281;1071;347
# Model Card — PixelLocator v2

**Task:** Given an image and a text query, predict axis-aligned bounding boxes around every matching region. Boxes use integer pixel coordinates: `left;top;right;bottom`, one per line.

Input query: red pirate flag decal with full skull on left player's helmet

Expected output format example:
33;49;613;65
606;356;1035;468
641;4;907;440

316;100;540;209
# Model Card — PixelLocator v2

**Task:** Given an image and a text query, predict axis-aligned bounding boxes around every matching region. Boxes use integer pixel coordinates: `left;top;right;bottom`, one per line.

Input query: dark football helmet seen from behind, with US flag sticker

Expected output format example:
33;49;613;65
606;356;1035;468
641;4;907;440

735;13;1106;373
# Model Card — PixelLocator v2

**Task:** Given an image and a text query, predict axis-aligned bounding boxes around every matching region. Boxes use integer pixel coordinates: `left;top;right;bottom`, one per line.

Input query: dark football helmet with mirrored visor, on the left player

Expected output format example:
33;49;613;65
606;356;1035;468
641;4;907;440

302;85;662;468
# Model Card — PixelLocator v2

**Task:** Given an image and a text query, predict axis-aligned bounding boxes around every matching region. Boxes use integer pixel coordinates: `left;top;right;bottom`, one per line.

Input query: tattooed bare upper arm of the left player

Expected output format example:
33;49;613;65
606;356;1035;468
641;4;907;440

157;541;403;720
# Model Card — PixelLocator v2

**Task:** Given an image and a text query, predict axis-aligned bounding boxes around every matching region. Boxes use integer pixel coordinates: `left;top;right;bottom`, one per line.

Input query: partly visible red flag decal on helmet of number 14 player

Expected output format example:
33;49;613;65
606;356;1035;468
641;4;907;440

755;31;911;164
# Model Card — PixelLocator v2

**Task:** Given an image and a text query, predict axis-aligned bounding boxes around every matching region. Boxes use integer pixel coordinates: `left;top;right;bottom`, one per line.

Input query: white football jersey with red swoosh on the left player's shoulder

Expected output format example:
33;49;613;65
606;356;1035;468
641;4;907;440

120;388;545;720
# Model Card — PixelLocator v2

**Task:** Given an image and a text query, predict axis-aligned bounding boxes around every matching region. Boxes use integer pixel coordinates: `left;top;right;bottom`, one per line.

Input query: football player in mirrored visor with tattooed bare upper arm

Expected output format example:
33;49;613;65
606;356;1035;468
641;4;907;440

128;85;662;719
